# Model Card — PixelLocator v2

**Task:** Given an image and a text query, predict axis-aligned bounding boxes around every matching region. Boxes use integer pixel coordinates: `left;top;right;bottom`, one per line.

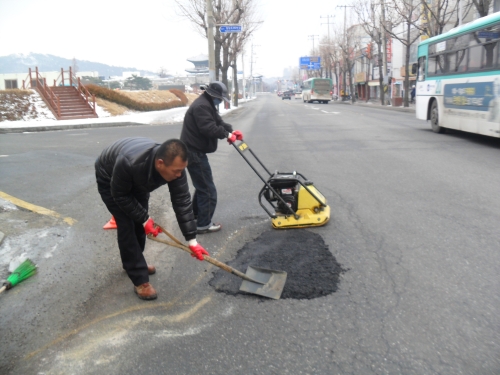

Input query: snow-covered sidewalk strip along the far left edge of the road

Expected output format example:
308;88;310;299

0;98;250;134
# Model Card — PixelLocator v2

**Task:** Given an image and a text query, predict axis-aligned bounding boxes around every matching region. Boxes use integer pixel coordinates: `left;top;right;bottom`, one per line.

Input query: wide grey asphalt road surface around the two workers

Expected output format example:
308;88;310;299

0;94;500;374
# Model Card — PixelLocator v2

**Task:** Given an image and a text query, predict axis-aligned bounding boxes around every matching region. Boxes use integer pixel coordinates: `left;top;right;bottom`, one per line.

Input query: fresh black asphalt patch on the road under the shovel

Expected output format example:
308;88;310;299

209;229;344;299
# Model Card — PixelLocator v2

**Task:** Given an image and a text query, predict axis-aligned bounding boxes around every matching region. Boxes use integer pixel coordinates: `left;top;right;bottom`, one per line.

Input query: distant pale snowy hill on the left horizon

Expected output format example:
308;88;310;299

0;53;156;78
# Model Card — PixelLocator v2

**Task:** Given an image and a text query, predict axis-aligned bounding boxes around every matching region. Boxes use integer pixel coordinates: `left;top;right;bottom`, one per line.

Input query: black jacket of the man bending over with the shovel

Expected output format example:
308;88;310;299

95;138;196;240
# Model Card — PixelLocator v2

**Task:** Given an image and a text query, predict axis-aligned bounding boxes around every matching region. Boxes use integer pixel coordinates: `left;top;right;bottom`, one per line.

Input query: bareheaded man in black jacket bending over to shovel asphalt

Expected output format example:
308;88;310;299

95;138;208;299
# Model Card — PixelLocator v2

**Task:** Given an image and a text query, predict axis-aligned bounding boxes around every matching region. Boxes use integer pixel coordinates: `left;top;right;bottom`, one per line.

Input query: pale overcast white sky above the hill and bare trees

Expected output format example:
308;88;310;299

0;0;348;77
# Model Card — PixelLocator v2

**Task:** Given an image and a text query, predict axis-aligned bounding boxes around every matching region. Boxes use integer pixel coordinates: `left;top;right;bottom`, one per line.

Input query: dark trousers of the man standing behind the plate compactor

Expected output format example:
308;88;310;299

187;150;217;230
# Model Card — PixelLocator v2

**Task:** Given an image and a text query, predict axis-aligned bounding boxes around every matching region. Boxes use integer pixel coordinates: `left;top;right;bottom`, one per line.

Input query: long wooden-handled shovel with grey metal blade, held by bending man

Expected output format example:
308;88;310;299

148;225;286;299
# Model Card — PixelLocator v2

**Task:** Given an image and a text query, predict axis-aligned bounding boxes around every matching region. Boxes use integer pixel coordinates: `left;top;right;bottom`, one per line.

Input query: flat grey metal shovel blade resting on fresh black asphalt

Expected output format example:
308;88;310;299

240;266;286;299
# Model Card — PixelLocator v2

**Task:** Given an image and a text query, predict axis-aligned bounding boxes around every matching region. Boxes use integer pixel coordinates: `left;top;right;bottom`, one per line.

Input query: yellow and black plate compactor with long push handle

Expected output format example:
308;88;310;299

233;141;330;229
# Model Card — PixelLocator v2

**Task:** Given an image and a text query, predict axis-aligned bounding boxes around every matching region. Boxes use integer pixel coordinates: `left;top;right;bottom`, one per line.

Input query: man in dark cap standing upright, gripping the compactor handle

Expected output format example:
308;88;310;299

181;81;243;234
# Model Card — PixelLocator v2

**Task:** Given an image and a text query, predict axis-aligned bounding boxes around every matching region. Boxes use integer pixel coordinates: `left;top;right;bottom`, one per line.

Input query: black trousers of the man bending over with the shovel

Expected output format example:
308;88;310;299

97;180;149;286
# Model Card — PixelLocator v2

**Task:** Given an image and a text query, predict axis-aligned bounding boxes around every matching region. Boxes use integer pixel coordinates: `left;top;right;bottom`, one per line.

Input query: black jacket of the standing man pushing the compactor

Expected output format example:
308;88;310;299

181;92;233;154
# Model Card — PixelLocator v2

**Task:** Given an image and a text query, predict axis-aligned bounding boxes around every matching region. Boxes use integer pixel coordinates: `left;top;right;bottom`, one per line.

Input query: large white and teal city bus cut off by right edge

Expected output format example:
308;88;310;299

416;13;500;137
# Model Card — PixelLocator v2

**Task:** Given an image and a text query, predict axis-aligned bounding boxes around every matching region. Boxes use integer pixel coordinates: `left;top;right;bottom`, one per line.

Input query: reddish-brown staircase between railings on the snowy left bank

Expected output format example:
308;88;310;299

50;86;98;120
